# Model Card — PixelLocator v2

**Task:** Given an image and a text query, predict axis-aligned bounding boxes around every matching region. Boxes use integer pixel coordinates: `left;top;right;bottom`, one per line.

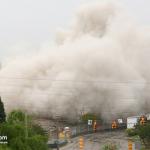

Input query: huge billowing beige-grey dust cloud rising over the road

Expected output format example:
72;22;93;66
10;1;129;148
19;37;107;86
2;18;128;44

0;2;150;119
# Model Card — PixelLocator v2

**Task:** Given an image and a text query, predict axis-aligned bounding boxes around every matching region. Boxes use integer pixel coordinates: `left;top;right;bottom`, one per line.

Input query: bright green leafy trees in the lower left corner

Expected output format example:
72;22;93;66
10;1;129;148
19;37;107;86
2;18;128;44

0;110;48;150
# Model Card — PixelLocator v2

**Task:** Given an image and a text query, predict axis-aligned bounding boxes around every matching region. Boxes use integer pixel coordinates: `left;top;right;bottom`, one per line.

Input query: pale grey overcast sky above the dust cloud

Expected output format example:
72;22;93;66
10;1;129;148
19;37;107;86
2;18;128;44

0;0;150;61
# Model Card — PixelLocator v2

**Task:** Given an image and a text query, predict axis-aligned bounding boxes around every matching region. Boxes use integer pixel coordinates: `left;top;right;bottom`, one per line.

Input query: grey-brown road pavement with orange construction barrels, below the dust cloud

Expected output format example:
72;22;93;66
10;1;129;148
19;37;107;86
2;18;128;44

60;131;134;150
